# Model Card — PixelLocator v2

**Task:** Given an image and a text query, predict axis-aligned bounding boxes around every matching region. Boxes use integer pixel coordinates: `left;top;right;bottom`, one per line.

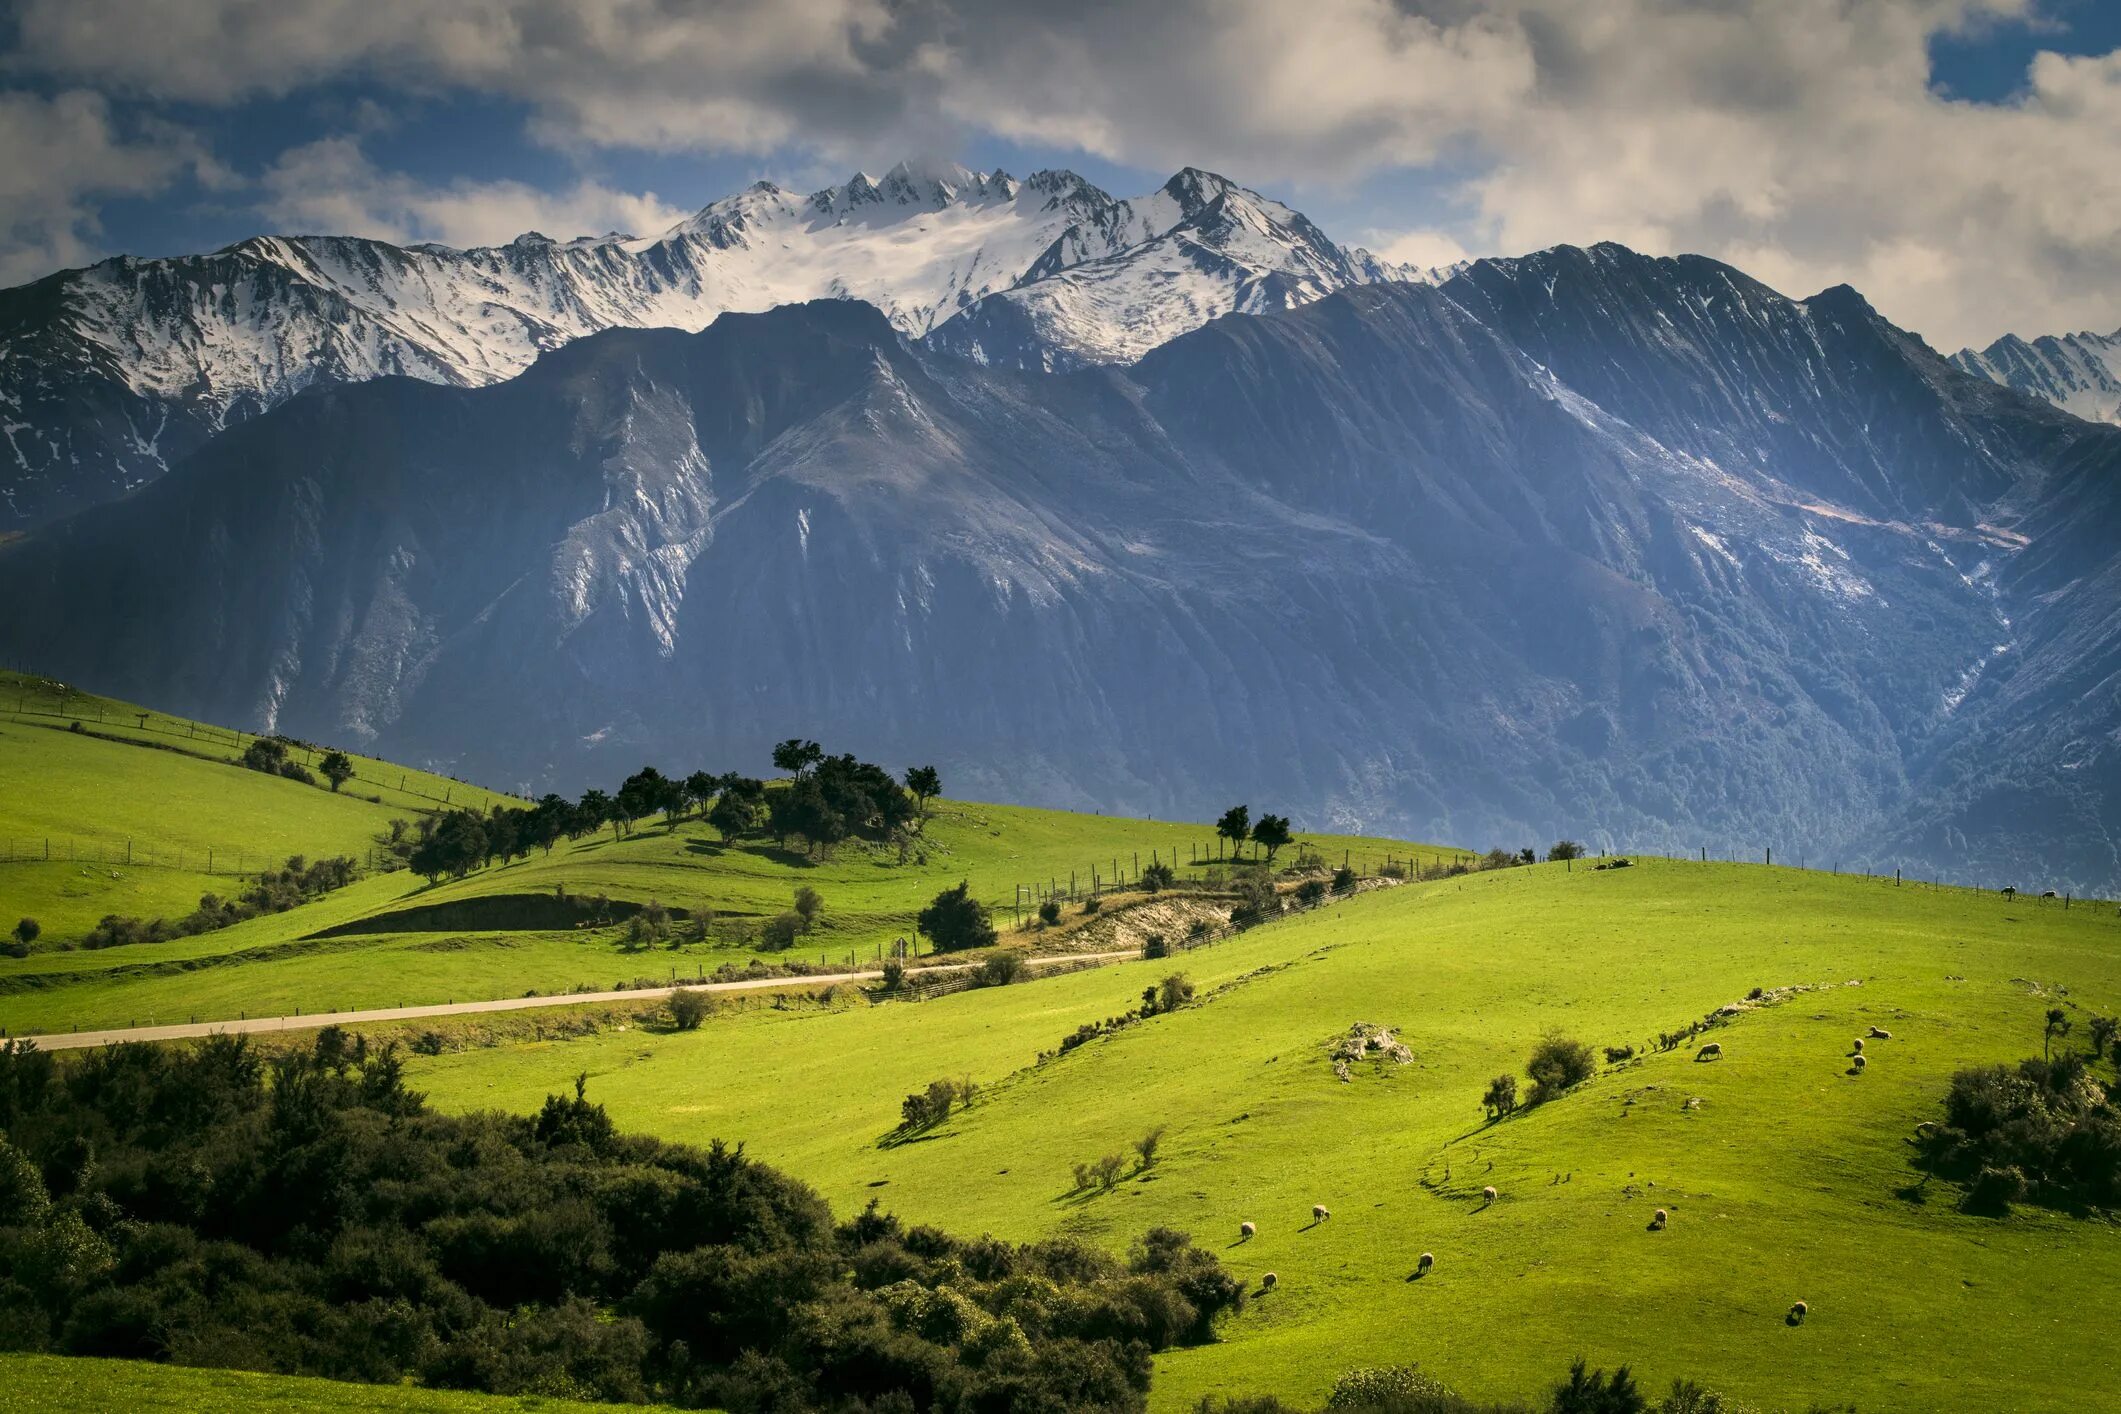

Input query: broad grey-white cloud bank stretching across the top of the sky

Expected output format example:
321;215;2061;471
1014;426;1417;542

13;0;2121;346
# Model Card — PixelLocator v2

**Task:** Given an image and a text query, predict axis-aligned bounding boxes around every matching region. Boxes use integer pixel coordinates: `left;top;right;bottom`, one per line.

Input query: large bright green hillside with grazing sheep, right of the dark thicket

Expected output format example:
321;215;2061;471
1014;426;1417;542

414;861;2121;1412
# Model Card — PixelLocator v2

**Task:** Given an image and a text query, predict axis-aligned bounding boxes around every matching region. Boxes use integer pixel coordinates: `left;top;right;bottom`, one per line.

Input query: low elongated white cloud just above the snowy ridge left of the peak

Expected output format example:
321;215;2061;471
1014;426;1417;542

259;138;687;246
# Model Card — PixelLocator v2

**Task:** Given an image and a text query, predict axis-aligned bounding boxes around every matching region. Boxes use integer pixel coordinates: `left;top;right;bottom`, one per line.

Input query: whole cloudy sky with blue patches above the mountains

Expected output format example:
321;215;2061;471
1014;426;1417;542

0;0;2121;350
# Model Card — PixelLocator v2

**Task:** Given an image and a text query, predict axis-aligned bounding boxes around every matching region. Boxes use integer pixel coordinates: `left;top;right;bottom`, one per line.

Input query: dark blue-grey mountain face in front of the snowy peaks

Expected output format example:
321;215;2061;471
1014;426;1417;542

0;248;2121;886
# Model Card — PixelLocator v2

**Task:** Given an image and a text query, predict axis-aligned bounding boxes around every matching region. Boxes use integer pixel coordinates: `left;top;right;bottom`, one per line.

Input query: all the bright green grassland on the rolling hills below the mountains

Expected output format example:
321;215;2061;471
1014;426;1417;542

0;681;2121;1414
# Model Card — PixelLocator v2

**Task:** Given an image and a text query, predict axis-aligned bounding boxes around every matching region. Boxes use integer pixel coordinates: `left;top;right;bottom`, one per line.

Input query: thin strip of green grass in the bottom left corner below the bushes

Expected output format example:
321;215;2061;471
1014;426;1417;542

0;1355;678;1414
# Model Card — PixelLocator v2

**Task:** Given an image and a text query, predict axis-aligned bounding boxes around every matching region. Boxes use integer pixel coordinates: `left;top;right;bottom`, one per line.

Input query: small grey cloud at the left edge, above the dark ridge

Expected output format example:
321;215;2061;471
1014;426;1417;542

0;89;221;286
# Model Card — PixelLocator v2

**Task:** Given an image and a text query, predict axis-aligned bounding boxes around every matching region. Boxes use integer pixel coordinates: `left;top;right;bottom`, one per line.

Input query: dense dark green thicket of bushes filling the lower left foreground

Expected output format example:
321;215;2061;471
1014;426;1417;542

0;1030;1243;1414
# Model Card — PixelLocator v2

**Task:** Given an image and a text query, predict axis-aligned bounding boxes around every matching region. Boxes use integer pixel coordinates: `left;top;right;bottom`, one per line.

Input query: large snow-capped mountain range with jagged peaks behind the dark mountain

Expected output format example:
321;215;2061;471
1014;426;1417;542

0;163;1417;530
